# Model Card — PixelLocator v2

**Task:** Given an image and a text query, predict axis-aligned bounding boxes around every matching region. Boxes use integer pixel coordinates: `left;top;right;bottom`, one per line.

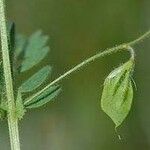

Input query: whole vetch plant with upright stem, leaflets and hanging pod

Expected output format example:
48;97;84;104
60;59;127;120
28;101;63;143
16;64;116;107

0;0;150;150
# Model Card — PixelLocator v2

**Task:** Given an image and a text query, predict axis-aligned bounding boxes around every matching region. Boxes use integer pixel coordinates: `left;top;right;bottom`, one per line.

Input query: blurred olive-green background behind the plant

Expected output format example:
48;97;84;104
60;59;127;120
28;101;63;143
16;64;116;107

0;0;150;150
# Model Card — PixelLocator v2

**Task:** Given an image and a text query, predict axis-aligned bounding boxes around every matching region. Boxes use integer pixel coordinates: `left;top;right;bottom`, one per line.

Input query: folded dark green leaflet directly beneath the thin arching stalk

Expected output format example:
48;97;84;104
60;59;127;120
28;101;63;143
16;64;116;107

24;85;61;108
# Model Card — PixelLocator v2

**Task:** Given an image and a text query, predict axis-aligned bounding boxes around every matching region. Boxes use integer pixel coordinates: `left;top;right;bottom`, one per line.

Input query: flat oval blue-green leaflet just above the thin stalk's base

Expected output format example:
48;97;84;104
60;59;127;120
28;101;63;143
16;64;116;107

20;66;51;92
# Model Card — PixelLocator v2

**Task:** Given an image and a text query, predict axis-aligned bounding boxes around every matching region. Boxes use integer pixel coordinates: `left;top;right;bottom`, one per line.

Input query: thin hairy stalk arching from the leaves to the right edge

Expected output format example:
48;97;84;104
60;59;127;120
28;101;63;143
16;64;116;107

25;30;150;103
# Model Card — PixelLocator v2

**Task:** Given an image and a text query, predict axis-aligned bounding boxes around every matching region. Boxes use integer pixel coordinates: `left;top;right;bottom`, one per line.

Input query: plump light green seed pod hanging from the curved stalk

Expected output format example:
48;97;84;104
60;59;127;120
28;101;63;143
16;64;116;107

101;60;133;127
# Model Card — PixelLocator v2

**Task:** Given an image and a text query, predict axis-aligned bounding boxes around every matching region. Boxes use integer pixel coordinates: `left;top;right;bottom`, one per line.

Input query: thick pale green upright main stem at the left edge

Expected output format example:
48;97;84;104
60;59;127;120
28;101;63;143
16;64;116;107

0;0;20;150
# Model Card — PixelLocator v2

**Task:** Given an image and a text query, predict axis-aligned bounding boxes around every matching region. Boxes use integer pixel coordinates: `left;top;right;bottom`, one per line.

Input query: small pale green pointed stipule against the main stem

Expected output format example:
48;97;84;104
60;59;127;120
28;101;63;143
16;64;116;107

16;91;26;120
